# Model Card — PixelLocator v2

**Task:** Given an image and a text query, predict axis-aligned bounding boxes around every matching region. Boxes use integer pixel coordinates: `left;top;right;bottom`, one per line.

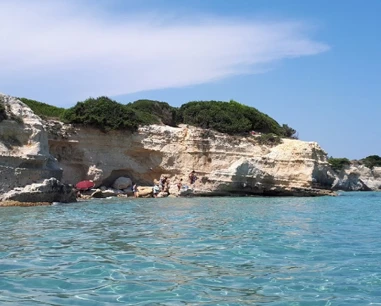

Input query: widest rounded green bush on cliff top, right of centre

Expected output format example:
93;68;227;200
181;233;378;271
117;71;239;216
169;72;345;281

177;100;284;135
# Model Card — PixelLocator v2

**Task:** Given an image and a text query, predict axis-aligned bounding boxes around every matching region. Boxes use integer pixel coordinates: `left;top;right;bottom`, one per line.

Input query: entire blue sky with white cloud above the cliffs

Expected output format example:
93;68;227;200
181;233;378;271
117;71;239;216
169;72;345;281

0;0;381;159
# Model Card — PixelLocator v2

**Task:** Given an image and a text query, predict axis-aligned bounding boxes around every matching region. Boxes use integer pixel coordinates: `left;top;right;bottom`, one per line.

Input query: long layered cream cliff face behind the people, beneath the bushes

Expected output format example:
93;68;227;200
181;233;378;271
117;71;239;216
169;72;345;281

49;125;335;195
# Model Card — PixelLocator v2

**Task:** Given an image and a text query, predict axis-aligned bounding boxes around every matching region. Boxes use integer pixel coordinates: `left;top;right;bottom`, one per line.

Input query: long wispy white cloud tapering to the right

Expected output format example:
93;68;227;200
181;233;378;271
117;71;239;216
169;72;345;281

0;0;329;105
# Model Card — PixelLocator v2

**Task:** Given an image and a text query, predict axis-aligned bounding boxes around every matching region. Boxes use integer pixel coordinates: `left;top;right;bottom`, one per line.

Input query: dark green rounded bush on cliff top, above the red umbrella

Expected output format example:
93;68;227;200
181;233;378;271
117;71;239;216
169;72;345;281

61;97;145;132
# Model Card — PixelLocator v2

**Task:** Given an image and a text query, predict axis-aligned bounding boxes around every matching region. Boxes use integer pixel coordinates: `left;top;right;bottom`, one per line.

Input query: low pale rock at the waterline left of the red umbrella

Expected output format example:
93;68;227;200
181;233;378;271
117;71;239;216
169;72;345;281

0;178;76;205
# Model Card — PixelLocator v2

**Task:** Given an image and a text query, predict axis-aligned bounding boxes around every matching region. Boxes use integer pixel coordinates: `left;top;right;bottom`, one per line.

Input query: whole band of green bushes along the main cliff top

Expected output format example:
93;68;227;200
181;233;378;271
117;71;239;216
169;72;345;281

14;97;296;137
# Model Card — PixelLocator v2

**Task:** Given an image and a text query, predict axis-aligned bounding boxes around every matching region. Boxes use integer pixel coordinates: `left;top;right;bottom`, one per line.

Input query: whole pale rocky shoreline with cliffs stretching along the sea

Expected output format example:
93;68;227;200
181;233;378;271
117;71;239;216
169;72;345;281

0;94;381;206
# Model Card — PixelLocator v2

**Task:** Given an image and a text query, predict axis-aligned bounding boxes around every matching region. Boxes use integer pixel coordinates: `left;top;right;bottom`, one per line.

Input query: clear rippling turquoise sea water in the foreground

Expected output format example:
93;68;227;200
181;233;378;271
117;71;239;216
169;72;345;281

0;193;381;306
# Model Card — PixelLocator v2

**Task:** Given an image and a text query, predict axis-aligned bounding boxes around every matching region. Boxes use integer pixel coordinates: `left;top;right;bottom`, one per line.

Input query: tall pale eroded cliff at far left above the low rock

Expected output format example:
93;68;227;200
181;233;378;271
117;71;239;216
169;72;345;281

0;94;62;193
